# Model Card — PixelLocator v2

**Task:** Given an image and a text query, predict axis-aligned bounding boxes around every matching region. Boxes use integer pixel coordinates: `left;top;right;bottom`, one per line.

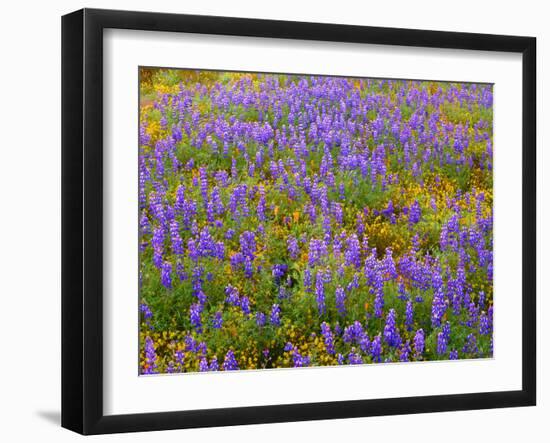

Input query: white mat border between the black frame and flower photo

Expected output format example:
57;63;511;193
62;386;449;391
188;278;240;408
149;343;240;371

103;30;522;414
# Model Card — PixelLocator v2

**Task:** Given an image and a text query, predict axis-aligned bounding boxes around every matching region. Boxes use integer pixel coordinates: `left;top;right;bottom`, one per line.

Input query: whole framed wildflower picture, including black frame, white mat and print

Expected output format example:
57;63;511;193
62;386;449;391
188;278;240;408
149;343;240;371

62;9;536;434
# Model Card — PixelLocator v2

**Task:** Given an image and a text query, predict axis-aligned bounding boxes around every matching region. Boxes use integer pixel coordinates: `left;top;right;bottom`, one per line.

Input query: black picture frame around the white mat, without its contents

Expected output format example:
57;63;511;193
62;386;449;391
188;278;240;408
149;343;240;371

62;9;536;434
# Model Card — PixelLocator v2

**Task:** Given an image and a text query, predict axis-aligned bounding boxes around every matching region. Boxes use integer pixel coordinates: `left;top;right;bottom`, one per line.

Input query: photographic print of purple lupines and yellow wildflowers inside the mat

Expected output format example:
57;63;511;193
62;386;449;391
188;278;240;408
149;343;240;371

138;67;494;375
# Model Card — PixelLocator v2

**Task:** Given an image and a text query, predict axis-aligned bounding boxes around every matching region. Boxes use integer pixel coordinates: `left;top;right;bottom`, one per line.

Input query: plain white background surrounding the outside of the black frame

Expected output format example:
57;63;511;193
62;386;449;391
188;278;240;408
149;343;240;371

0;0;550;442
